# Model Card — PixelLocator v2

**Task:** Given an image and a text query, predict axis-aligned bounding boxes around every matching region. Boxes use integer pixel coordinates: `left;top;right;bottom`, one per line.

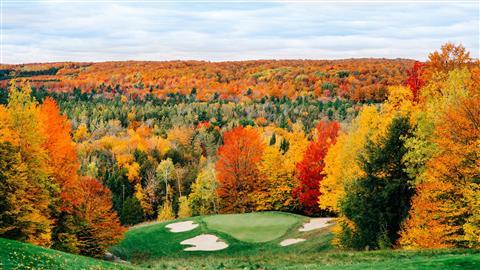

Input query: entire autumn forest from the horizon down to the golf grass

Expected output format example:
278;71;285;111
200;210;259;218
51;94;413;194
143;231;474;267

0;43;480;257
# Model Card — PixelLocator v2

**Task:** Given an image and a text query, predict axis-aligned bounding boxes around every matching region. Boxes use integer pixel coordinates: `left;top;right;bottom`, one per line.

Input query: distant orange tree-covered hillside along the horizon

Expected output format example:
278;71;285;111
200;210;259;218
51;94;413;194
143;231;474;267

0;58;413;101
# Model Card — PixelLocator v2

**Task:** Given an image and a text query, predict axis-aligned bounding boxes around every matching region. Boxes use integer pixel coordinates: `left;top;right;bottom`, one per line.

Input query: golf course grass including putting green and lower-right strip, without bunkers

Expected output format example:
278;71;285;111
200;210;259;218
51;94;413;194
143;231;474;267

111;212;480;270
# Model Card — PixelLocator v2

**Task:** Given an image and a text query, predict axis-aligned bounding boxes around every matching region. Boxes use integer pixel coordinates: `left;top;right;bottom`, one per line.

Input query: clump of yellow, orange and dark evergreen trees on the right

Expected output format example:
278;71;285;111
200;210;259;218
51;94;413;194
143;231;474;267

312;43;480;249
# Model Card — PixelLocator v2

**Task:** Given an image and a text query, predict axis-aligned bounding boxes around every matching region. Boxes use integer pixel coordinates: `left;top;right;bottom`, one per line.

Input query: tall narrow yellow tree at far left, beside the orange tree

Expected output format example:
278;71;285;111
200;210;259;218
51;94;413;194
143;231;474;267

0;84;52;246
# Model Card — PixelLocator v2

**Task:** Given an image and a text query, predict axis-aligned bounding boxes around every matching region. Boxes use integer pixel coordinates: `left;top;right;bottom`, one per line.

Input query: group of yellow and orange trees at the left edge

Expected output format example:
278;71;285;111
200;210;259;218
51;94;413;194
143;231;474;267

0;85;123;256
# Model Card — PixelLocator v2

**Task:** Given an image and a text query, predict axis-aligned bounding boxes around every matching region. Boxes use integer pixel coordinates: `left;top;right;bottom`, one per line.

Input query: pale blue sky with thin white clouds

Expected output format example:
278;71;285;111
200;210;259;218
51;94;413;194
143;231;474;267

0;0;480;64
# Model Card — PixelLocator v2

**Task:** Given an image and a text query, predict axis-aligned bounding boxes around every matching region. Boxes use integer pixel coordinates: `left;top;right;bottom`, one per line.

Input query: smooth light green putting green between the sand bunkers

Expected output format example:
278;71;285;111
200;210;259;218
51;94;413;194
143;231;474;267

203;212;302;243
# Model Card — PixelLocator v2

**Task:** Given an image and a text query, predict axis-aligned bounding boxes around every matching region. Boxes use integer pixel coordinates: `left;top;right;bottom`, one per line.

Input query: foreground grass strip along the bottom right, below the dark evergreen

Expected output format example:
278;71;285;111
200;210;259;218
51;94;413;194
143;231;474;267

143;250;480;270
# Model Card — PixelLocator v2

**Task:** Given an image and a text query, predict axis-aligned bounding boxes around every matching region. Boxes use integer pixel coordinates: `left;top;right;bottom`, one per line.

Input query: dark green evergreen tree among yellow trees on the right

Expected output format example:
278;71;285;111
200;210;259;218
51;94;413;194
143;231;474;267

338;117;413;249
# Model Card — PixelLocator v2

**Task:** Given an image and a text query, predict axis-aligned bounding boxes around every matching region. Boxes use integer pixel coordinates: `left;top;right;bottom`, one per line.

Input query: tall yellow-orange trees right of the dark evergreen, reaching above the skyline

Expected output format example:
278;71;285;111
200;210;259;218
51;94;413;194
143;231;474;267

400;49;480;248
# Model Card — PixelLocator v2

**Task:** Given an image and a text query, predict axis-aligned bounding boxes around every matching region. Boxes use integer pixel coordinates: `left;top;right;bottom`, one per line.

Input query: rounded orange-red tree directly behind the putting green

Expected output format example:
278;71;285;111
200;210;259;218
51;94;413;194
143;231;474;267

216;127;265;213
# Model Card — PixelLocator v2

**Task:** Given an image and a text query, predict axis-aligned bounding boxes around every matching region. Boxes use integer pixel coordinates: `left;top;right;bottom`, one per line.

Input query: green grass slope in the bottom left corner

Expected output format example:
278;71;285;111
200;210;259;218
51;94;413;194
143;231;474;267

0;238;133;270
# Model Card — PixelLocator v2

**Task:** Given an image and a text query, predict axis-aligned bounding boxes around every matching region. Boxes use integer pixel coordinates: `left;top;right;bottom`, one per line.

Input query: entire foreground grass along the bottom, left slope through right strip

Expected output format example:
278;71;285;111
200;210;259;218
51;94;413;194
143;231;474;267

0;238;480;270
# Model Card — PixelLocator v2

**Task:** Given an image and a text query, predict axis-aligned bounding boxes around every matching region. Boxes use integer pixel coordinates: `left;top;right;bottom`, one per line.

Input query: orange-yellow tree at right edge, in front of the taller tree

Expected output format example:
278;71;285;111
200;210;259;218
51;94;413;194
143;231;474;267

401;93;480;248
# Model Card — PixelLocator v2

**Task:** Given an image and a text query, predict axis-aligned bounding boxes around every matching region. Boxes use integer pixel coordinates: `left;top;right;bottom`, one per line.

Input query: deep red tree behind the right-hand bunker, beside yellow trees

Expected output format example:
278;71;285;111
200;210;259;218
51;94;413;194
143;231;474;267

293;121;340;215
